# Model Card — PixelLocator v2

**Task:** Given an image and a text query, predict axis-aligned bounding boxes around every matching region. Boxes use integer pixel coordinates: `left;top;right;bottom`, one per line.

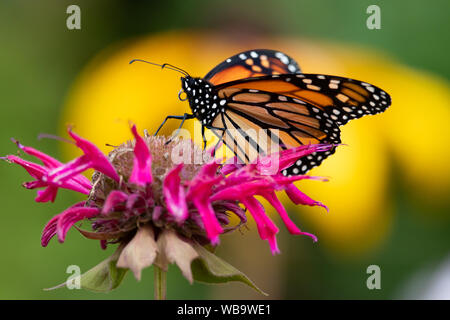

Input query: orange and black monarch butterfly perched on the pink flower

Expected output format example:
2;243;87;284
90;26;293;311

130;49;391;176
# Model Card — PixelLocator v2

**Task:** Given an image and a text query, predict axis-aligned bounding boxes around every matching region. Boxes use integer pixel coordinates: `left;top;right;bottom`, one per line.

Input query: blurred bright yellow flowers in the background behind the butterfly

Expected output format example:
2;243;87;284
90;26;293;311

61;32;450;254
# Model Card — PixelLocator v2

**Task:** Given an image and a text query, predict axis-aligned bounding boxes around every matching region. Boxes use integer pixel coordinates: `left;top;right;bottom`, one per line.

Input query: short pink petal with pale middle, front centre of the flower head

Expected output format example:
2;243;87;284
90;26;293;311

163;163;188;223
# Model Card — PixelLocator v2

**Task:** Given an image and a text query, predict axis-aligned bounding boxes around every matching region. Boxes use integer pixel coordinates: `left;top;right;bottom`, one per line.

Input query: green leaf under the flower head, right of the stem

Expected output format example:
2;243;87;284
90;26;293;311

191;244;268;296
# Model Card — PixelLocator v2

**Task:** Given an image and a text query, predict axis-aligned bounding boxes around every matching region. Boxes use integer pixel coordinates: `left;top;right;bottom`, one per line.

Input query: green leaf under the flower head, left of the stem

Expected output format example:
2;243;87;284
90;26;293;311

45;246;128;292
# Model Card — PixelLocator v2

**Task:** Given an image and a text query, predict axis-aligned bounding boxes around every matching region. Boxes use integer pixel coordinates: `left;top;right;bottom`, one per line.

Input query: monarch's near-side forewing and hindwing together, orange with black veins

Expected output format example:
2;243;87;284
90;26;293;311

213;74;391;175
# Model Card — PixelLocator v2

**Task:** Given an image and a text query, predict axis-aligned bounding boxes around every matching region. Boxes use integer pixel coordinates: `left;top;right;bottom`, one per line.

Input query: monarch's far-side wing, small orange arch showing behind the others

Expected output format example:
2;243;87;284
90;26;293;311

204;49;301;86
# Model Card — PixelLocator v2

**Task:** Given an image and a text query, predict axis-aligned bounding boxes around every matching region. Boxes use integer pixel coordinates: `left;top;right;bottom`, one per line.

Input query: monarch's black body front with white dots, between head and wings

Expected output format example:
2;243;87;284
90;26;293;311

181;77;224;126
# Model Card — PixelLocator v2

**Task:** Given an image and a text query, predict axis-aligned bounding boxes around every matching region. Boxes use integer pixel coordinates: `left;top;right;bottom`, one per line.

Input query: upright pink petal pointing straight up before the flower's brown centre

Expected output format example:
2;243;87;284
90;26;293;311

129;125;152;186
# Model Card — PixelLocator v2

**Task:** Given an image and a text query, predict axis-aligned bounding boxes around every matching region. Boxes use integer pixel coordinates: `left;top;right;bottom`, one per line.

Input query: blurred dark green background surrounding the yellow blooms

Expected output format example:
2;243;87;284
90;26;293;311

0;0;450;299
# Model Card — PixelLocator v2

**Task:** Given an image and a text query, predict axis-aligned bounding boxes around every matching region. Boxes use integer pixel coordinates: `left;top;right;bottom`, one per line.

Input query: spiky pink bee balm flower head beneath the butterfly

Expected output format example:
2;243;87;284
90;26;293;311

4;126;333;294
